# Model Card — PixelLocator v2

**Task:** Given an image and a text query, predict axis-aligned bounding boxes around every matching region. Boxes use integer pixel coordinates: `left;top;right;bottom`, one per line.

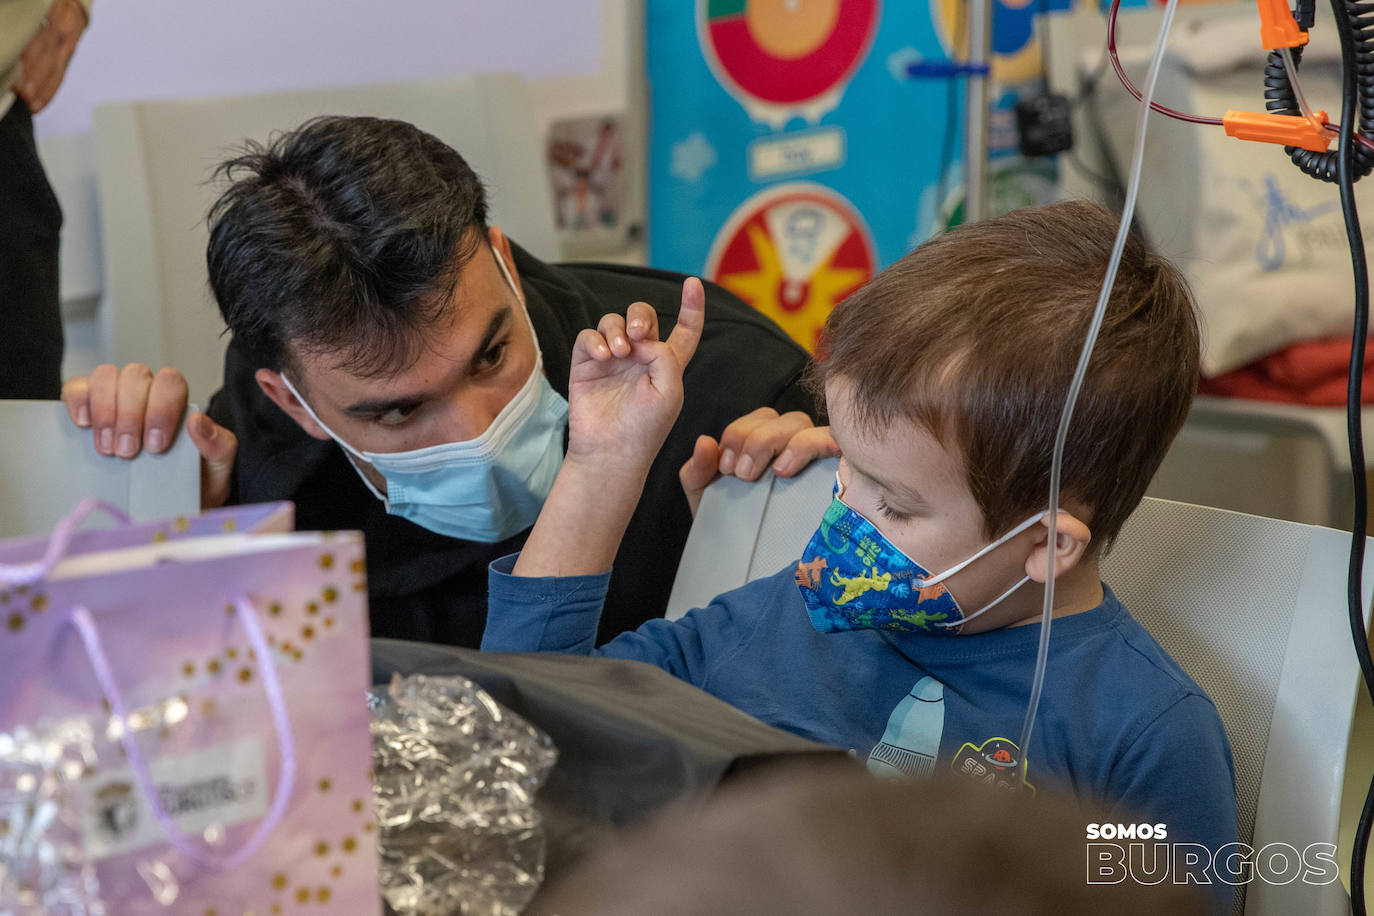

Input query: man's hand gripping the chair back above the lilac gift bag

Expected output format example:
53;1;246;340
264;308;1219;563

62;365;239;509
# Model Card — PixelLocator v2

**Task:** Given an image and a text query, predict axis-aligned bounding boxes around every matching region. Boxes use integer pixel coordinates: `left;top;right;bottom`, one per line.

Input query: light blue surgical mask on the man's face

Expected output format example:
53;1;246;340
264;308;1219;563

282;254;567;544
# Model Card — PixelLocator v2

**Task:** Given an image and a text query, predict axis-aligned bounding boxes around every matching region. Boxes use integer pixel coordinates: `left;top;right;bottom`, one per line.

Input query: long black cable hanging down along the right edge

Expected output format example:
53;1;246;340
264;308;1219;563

1330;0;1374;916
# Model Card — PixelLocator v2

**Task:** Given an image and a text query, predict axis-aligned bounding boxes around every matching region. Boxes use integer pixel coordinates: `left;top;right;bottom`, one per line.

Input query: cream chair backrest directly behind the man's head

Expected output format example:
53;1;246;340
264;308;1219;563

95;74;556;401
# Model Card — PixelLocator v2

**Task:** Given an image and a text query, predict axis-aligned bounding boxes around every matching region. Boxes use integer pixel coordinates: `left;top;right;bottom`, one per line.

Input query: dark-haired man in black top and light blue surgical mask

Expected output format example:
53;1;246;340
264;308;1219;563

63;117;833;645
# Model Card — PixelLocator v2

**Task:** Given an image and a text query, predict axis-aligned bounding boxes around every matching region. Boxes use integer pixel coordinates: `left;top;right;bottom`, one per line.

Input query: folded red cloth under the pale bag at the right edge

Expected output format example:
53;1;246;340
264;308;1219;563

1198;338;1374;407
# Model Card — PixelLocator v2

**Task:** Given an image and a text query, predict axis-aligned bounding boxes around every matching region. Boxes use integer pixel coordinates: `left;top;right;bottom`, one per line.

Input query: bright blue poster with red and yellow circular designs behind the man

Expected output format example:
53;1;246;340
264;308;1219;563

646;0;1070;347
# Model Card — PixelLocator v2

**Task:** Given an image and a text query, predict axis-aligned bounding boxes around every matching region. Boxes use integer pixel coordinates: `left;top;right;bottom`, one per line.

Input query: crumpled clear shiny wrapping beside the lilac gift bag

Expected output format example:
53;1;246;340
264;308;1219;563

370;674;558;916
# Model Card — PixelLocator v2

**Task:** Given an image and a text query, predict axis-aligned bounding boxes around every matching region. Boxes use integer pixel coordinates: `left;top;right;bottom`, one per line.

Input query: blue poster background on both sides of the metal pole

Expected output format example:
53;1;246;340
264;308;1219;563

646;0;1070;347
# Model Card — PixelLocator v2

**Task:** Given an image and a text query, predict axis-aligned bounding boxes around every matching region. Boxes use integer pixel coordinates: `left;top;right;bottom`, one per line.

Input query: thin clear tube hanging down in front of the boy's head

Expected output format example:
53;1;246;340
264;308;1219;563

1017;0;1179;777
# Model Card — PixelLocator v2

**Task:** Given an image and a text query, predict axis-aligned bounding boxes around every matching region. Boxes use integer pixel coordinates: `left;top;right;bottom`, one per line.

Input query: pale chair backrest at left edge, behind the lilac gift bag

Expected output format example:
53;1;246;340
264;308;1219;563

0;401;201;538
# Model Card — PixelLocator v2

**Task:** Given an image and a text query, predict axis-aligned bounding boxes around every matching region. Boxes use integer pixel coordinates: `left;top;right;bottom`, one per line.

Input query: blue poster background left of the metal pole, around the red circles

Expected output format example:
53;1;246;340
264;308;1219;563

647;0;960;272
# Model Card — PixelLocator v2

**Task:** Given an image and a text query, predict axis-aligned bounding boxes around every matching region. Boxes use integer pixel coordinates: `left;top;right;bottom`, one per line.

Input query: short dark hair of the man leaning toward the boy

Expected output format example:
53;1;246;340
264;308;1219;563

206;117;486;382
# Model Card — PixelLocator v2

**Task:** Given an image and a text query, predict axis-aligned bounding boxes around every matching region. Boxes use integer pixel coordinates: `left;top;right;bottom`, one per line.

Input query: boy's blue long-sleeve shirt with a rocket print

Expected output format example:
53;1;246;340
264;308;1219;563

482;556;1237;909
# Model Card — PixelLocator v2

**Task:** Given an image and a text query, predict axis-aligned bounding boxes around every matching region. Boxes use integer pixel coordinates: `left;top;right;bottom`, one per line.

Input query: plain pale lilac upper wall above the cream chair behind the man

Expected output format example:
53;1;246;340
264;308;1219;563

37;0;603;136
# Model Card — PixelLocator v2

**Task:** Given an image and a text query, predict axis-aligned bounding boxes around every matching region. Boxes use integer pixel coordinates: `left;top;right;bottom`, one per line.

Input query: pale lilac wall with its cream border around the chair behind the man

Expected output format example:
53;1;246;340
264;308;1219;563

26;0;643;375
